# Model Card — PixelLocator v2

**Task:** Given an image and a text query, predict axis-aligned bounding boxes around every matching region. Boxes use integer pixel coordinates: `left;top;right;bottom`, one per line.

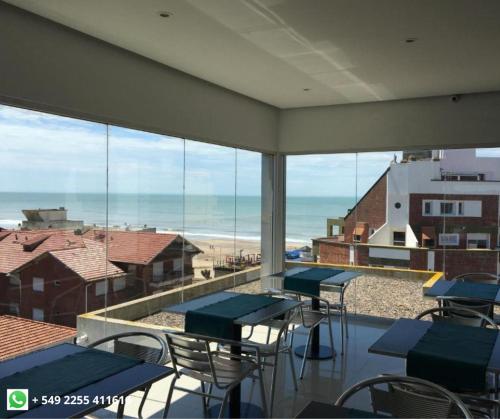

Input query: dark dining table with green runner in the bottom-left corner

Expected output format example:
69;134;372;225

0;343;174;418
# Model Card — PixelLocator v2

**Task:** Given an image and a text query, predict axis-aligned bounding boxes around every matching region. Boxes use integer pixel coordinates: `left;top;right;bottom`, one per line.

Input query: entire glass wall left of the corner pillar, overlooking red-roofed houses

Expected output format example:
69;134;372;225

0;106;261;338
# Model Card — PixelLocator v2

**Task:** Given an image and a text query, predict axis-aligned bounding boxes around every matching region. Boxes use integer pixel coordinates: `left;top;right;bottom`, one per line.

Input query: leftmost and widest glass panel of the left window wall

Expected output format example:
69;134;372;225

0;105;107;348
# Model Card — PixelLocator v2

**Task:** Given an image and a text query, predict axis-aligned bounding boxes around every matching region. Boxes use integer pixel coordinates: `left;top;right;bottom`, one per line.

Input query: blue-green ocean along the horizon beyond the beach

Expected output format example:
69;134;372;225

0;192;355;244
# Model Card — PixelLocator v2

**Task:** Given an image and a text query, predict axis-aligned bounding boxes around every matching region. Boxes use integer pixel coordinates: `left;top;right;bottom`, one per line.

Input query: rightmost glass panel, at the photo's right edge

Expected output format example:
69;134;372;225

438;148;500;282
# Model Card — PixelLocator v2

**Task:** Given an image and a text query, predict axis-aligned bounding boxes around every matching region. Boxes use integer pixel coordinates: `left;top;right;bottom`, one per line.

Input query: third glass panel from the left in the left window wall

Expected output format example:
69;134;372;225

184;140;239;288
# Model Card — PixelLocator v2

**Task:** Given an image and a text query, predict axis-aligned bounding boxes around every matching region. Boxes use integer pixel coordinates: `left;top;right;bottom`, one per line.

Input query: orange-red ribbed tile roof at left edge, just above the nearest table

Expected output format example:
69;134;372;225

0;316;76;361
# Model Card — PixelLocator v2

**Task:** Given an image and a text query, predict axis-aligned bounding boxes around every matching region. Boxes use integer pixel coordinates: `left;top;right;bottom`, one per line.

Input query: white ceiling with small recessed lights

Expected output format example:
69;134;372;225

7;0;500;108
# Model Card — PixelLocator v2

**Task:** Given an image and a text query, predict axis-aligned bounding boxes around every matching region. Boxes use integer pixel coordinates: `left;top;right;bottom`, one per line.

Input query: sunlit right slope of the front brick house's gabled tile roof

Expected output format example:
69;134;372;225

49;239;125;281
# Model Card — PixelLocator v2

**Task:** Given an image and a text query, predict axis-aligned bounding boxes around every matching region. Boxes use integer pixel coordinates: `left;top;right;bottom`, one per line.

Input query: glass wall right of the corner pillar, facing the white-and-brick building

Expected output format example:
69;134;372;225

286;149;500;317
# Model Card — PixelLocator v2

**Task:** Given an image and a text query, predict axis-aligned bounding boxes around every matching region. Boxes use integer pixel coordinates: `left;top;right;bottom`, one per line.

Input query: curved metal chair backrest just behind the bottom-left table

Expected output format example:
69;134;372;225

88;332;168;365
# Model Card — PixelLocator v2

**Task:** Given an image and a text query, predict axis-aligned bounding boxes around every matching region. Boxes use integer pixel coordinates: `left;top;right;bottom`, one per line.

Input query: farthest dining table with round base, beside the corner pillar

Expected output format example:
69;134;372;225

263;266;362;360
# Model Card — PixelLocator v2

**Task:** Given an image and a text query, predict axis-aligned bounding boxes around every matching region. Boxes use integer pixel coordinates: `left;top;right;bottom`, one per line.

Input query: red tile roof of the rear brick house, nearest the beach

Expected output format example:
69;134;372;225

84;230;188;265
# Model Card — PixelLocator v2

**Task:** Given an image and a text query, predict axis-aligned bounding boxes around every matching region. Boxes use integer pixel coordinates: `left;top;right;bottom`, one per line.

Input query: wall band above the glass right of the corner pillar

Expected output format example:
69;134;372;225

278;92;500;153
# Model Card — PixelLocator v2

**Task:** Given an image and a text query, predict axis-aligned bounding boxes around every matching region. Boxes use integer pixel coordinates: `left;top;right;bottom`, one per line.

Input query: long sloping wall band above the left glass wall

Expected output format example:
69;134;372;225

0;1;278;152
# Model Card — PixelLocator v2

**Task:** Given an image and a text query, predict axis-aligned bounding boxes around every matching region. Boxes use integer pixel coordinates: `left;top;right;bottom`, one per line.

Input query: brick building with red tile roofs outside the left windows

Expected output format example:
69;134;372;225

0;230;200;326
